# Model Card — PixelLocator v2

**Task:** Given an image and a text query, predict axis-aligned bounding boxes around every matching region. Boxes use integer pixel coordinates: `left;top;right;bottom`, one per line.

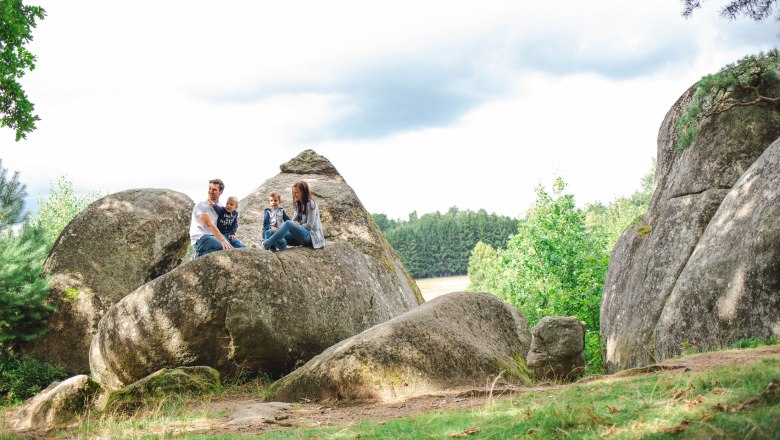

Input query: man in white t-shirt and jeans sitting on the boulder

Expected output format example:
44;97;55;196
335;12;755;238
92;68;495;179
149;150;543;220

190;179;233;257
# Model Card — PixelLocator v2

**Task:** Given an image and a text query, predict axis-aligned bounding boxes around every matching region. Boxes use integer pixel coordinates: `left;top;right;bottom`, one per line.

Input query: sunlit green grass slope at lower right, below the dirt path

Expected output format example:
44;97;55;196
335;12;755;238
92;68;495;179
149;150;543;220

239;359;780;439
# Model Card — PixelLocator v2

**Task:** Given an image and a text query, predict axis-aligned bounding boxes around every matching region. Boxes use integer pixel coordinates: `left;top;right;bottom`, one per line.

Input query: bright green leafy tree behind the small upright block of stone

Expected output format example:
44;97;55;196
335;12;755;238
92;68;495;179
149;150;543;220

469;178;611;371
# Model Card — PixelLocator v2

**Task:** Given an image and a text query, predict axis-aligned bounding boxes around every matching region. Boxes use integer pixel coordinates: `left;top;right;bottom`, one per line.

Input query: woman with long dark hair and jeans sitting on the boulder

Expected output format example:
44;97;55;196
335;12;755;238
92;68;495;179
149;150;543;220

263;180;325;250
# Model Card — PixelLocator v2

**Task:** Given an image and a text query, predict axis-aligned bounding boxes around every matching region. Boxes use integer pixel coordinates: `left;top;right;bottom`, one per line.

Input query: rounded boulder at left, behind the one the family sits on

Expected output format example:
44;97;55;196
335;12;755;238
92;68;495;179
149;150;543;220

23;189;193;373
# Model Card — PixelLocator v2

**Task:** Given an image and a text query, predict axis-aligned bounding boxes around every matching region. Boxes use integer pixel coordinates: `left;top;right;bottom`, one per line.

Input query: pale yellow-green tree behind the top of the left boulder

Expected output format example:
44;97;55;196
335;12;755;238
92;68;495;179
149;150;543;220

30;176;103;248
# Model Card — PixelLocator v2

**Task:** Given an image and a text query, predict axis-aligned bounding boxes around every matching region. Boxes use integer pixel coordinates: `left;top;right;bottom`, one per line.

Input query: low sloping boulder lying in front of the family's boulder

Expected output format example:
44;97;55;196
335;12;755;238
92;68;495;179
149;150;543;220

270;292;531;402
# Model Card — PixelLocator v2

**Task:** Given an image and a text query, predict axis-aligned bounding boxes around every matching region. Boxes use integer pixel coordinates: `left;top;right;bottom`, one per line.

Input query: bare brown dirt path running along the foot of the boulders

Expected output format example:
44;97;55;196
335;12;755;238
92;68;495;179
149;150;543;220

7;345;780;439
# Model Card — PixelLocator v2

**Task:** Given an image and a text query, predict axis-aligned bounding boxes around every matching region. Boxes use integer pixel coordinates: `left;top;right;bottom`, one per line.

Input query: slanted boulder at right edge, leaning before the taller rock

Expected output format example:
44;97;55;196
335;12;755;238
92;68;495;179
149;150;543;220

654;139;780;358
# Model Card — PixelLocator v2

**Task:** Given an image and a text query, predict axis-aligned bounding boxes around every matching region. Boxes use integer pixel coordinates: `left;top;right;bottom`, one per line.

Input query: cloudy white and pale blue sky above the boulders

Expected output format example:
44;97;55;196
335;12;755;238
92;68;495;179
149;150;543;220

0;0;780;219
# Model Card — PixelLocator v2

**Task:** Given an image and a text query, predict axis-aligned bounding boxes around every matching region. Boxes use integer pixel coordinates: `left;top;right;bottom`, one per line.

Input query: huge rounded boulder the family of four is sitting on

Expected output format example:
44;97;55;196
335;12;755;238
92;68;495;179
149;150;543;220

90;241;426;389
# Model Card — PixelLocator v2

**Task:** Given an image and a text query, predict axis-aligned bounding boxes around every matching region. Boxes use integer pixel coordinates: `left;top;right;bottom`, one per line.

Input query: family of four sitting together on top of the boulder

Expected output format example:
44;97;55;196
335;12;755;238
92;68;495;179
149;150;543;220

190;179;325;259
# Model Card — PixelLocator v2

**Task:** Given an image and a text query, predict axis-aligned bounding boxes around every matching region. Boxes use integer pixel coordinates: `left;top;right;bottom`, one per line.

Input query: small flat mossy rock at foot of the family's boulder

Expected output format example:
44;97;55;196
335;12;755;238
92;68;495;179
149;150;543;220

98;366;222;411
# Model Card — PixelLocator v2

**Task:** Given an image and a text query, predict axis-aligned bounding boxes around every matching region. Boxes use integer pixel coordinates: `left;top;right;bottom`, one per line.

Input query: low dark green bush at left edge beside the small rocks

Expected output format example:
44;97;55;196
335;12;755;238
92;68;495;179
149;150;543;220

0;353;68;406
